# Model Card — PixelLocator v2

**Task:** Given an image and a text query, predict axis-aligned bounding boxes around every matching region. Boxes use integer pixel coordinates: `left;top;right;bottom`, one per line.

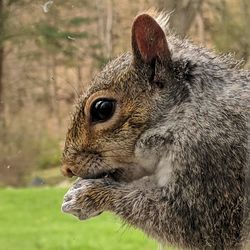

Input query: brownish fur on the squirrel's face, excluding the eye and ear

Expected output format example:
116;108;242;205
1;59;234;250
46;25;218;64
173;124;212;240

62;54;157;180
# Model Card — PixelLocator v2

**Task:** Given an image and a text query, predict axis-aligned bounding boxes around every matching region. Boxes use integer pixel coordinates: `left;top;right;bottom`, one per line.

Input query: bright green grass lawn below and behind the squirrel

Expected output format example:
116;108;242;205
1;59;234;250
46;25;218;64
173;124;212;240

0;188;162;250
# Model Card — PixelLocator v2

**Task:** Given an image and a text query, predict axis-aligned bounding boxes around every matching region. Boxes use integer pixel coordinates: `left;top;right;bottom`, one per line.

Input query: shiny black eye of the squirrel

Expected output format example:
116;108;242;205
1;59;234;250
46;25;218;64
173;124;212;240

90;99;116;122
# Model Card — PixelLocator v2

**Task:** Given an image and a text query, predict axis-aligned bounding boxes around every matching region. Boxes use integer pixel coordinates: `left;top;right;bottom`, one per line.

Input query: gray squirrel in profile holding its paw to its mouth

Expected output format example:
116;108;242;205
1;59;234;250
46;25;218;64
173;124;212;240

61;12;250;249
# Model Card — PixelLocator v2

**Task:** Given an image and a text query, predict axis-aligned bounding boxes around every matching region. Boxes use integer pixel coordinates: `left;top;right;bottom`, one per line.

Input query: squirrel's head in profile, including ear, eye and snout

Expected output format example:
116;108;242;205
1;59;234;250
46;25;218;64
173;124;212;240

62;14;188;181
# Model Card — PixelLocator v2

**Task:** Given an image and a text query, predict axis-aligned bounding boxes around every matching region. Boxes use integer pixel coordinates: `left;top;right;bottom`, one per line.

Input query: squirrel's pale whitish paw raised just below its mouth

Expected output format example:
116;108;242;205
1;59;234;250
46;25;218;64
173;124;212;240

62;179;102;220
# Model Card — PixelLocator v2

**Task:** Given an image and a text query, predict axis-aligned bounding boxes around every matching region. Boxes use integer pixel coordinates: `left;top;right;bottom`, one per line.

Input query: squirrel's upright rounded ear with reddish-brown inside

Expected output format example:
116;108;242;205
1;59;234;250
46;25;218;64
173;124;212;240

132;14;171;64
